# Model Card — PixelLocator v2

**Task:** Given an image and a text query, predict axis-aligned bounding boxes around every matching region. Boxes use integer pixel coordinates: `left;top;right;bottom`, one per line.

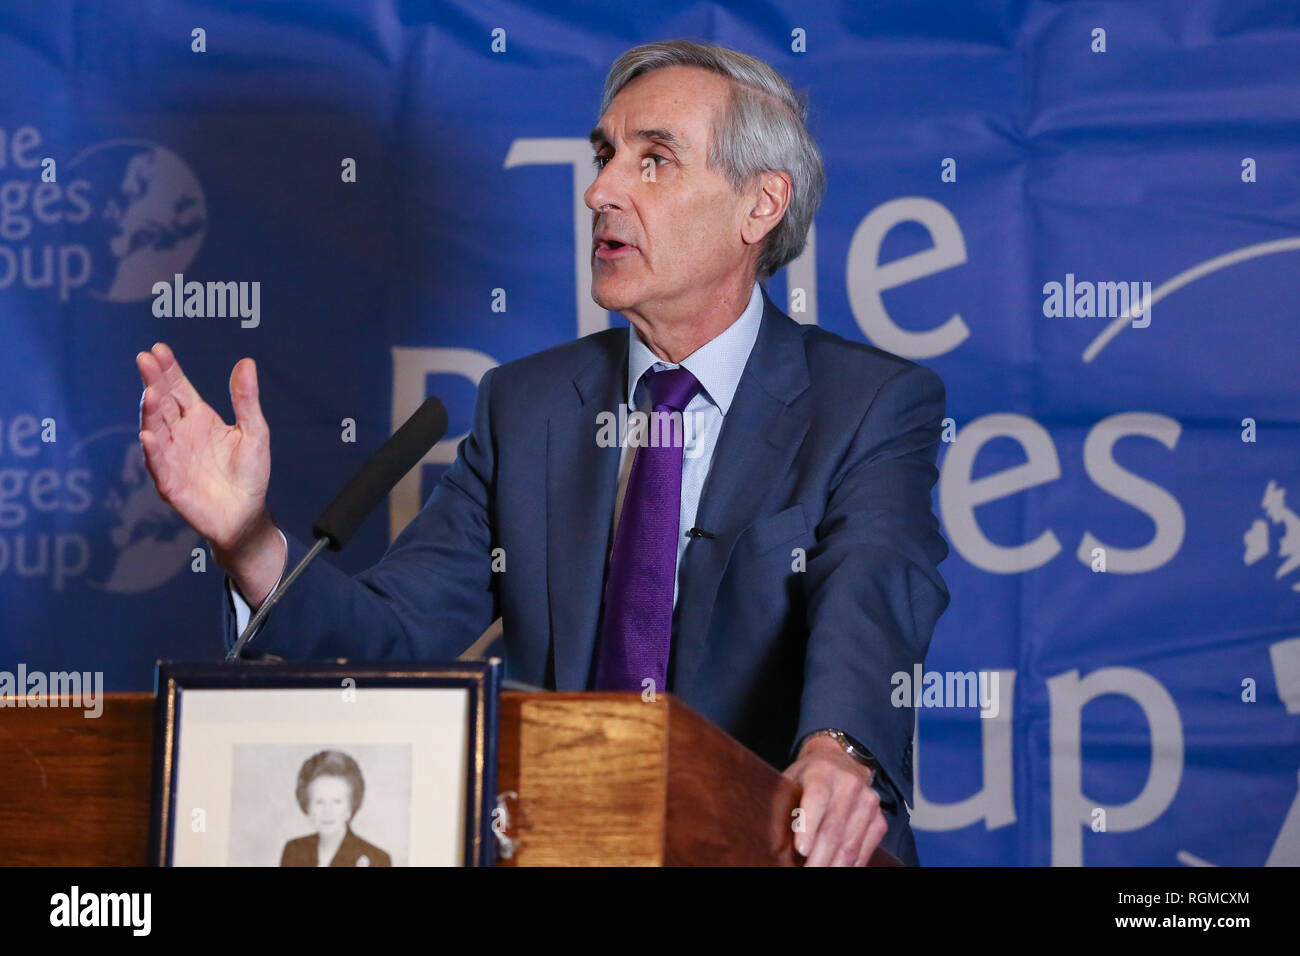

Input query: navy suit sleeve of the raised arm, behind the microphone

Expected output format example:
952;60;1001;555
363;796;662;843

224;369;498;661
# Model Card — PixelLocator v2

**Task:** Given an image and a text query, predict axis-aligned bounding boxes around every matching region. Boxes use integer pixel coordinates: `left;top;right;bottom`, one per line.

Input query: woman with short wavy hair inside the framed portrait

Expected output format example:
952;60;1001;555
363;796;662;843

280;750;393;866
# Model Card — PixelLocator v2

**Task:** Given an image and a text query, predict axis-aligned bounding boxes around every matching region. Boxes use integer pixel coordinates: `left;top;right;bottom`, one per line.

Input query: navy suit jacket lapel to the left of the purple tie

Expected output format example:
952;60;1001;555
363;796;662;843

546;329;628;691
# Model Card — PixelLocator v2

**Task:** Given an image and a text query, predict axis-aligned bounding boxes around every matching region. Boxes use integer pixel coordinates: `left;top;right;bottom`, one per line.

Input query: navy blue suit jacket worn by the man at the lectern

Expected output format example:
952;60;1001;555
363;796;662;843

226;291;948;857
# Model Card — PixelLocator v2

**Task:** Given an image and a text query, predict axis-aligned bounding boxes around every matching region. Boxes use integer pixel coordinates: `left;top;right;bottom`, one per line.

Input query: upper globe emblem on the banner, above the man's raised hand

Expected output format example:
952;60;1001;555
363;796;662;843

68;139;208;302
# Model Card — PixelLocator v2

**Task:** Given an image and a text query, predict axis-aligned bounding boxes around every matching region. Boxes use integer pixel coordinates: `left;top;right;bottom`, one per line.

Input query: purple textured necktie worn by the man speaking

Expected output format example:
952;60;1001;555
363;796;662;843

594;368;699;693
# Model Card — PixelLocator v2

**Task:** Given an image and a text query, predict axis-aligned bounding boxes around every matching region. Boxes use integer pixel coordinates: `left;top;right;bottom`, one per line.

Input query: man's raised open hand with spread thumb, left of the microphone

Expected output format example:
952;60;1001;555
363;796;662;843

135;342;283;604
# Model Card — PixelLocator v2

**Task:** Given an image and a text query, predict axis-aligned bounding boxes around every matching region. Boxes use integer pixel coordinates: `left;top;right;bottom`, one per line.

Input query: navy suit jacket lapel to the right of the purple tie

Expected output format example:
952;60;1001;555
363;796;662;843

672;291;811;693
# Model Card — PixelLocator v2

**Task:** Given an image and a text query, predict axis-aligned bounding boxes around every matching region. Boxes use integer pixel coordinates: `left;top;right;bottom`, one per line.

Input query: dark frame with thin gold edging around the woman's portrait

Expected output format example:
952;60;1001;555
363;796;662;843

150;658;502;866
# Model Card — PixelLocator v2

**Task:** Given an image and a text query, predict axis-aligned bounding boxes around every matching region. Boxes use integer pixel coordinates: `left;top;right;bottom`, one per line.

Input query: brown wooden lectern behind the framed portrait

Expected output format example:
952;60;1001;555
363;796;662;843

0;692;897;866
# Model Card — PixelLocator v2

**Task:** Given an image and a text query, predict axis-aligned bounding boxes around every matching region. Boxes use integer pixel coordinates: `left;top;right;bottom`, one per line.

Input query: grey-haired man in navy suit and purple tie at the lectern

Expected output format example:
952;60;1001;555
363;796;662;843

138;42;948;865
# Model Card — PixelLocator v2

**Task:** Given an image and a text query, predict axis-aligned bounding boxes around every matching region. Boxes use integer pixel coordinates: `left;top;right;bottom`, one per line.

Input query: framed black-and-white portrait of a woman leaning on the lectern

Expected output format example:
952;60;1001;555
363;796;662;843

150;658;501;866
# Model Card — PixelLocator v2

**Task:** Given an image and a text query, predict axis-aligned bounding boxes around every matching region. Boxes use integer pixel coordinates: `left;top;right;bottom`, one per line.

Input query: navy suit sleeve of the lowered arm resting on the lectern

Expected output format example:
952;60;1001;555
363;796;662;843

794;365;949;805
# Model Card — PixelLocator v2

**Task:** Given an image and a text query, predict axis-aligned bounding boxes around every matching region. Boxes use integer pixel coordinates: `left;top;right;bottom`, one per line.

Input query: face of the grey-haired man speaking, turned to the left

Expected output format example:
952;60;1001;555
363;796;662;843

585;66;751;312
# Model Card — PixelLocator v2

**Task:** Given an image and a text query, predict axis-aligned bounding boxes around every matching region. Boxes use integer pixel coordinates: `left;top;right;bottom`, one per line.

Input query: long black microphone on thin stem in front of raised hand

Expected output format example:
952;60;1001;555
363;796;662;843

226;398;447;662
